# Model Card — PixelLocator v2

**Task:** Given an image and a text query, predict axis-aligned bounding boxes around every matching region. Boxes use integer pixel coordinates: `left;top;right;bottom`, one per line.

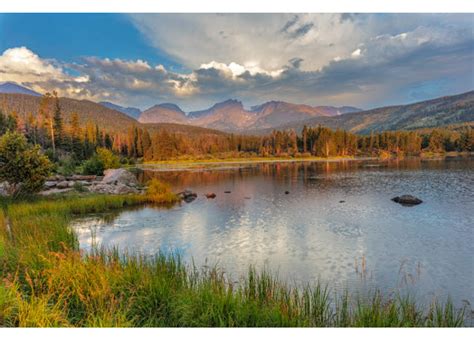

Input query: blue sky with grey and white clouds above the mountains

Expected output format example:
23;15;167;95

0;13;474;111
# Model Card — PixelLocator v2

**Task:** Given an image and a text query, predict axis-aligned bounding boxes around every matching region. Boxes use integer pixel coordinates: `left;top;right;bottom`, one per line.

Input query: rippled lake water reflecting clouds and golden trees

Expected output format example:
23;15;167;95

74;158;474;306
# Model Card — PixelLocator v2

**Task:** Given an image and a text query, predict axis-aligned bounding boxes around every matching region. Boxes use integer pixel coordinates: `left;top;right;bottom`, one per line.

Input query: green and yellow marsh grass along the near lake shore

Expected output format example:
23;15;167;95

0;193;465;327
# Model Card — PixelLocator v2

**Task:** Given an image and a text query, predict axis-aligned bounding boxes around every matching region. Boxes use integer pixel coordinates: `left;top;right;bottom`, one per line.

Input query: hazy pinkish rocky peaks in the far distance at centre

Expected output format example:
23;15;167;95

138;99;361;132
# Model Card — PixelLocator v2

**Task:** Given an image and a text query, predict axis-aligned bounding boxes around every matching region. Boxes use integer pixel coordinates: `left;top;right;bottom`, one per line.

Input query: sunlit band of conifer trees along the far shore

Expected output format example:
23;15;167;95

0;93;474;162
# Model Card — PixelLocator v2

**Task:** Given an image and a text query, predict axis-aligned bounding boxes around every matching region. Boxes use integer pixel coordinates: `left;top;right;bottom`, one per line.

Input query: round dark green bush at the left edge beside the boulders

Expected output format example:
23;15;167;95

0;132;52;196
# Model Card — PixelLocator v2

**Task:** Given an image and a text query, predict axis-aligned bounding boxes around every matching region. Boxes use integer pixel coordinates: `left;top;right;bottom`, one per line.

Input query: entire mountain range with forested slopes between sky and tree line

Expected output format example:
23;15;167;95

0;82;474;135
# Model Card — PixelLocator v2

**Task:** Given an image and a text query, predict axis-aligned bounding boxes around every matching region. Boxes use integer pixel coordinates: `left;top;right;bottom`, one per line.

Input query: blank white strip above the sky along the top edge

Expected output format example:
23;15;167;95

0;0;474;13
